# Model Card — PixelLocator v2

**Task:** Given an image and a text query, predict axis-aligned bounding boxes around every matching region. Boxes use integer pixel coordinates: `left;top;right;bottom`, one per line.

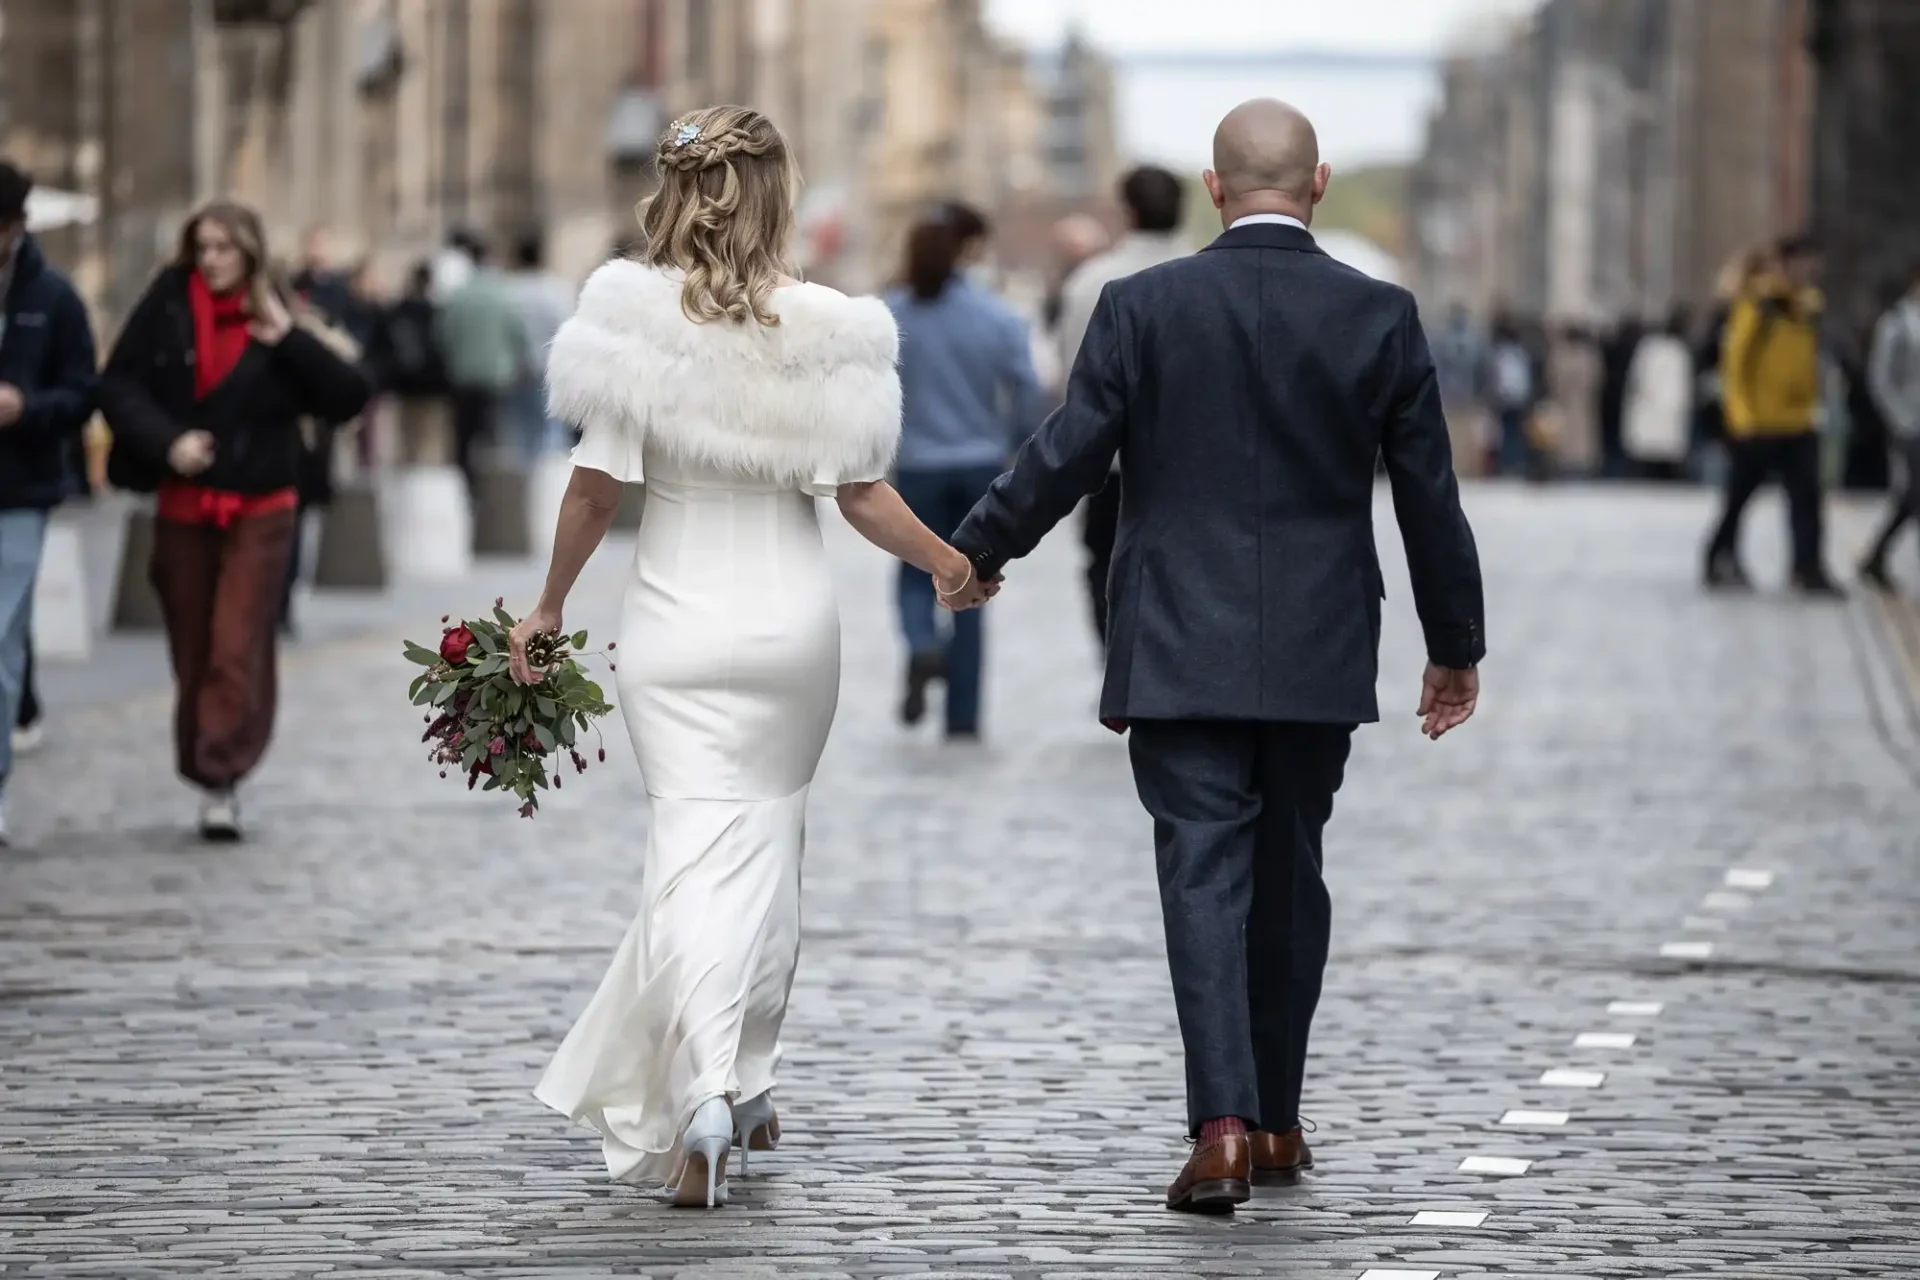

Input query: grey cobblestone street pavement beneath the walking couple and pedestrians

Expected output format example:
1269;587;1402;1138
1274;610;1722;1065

0;489;1920;1280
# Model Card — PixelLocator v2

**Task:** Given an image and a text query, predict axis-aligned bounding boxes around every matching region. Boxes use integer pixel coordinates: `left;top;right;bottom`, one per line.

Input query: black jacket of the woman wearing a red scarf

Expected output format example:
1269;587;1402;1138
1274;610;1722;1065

100;267;372;493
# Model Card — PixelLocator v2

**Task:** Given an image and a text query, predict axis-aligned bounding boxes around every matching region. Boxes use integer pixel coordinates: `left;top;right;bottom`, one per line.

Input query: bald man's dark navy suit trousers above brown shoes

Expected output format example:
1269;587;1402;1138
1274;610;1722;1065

1131;720;1354;1134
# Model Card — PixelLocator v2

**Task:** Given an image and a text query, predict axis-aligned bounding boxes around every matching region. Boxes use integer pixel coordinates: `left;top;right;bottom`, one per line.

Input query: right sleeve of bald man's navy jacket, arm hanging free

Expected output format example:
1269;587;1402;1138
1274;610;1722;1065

1380;299;1486;670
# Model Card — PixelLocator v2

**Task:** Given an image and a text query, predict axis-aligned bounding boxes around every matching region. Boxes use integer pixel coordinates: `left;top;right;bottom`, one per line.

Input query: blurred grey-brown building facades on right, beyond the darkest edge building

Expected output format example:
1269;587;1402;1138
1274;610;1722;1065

1407;0;1814;324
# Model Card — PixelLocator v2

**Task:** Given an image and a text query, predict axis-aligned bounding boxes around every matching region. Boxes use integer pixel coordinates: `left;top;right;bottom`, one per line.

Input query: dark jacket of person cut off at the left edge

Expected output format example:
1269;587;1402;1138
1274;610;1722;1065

0;236;96;510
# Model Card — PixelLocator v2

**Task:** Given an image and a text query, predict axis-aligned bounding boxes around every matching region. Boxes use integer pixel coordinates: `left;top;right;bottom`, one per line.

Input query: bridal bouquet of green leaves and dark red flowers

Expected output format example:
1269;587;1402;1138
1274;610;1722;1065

405;599;612;818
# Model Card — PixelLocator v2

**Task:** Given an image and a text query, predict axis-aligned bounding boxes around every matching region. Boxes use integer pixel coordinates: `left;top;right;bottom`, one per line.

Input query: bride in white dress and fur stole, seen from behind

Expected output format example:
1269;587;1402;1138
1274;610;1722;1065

511;107;993;1207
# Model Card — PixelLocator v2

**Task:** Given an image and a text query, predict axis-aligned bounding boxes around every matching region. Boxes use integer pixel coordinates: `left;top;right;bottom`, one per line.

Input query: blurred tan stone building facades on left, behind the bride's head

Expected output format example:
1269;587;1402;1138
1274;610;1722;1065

0;0;1117;330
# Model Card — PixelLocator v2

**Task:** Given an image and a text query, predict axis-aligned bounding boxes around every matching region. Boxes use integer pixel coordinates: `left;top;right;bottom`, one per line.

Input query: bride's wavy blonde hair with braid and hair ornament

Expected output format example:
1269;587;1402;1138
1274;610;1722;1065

639;107;799;324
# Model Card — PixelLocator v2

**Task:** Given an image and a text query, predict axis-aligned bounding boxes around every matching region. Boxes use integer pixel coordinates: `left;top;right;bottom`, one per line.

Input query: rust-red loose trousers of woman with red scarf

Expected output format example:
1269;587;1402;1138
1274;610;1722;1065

150;510;300;791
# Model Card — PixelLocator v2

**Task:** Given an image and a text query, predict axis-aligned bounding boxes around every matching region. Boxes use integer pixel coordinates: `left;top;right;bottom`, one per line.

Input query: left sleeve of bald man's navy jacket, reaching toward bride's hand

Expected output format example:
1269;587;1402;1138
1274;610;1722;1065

952;288;1127;578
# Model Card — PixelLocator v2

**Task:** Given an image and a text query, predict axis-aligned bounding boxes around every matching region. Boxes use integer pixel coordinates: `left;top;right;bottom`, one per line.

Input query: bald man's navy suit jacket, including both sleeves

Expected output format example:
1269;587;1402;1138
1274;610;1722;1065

952;223;1486;723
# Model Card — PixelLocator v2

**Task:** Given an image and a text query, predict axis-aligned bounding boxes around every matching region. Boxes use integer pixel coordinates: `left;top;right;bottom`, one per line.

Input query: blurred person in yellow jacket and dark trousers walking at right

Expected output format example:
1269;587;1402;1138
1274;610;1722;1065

1705;236;1839;595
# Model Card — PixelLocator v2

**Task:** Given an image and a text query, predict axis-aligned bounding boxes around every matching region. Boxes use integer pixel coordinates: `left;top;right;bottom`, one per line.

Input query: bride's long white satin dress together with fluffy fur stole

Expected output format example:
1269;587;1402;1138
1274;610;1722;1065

536;261;899;1182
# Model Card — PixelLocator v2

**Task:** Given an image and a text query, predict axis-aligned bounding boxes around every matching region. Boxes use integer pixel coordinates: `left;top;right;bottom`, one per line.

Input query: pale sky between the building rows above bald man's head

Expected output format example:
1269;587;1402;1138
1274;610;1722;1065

987;0;1536;171
